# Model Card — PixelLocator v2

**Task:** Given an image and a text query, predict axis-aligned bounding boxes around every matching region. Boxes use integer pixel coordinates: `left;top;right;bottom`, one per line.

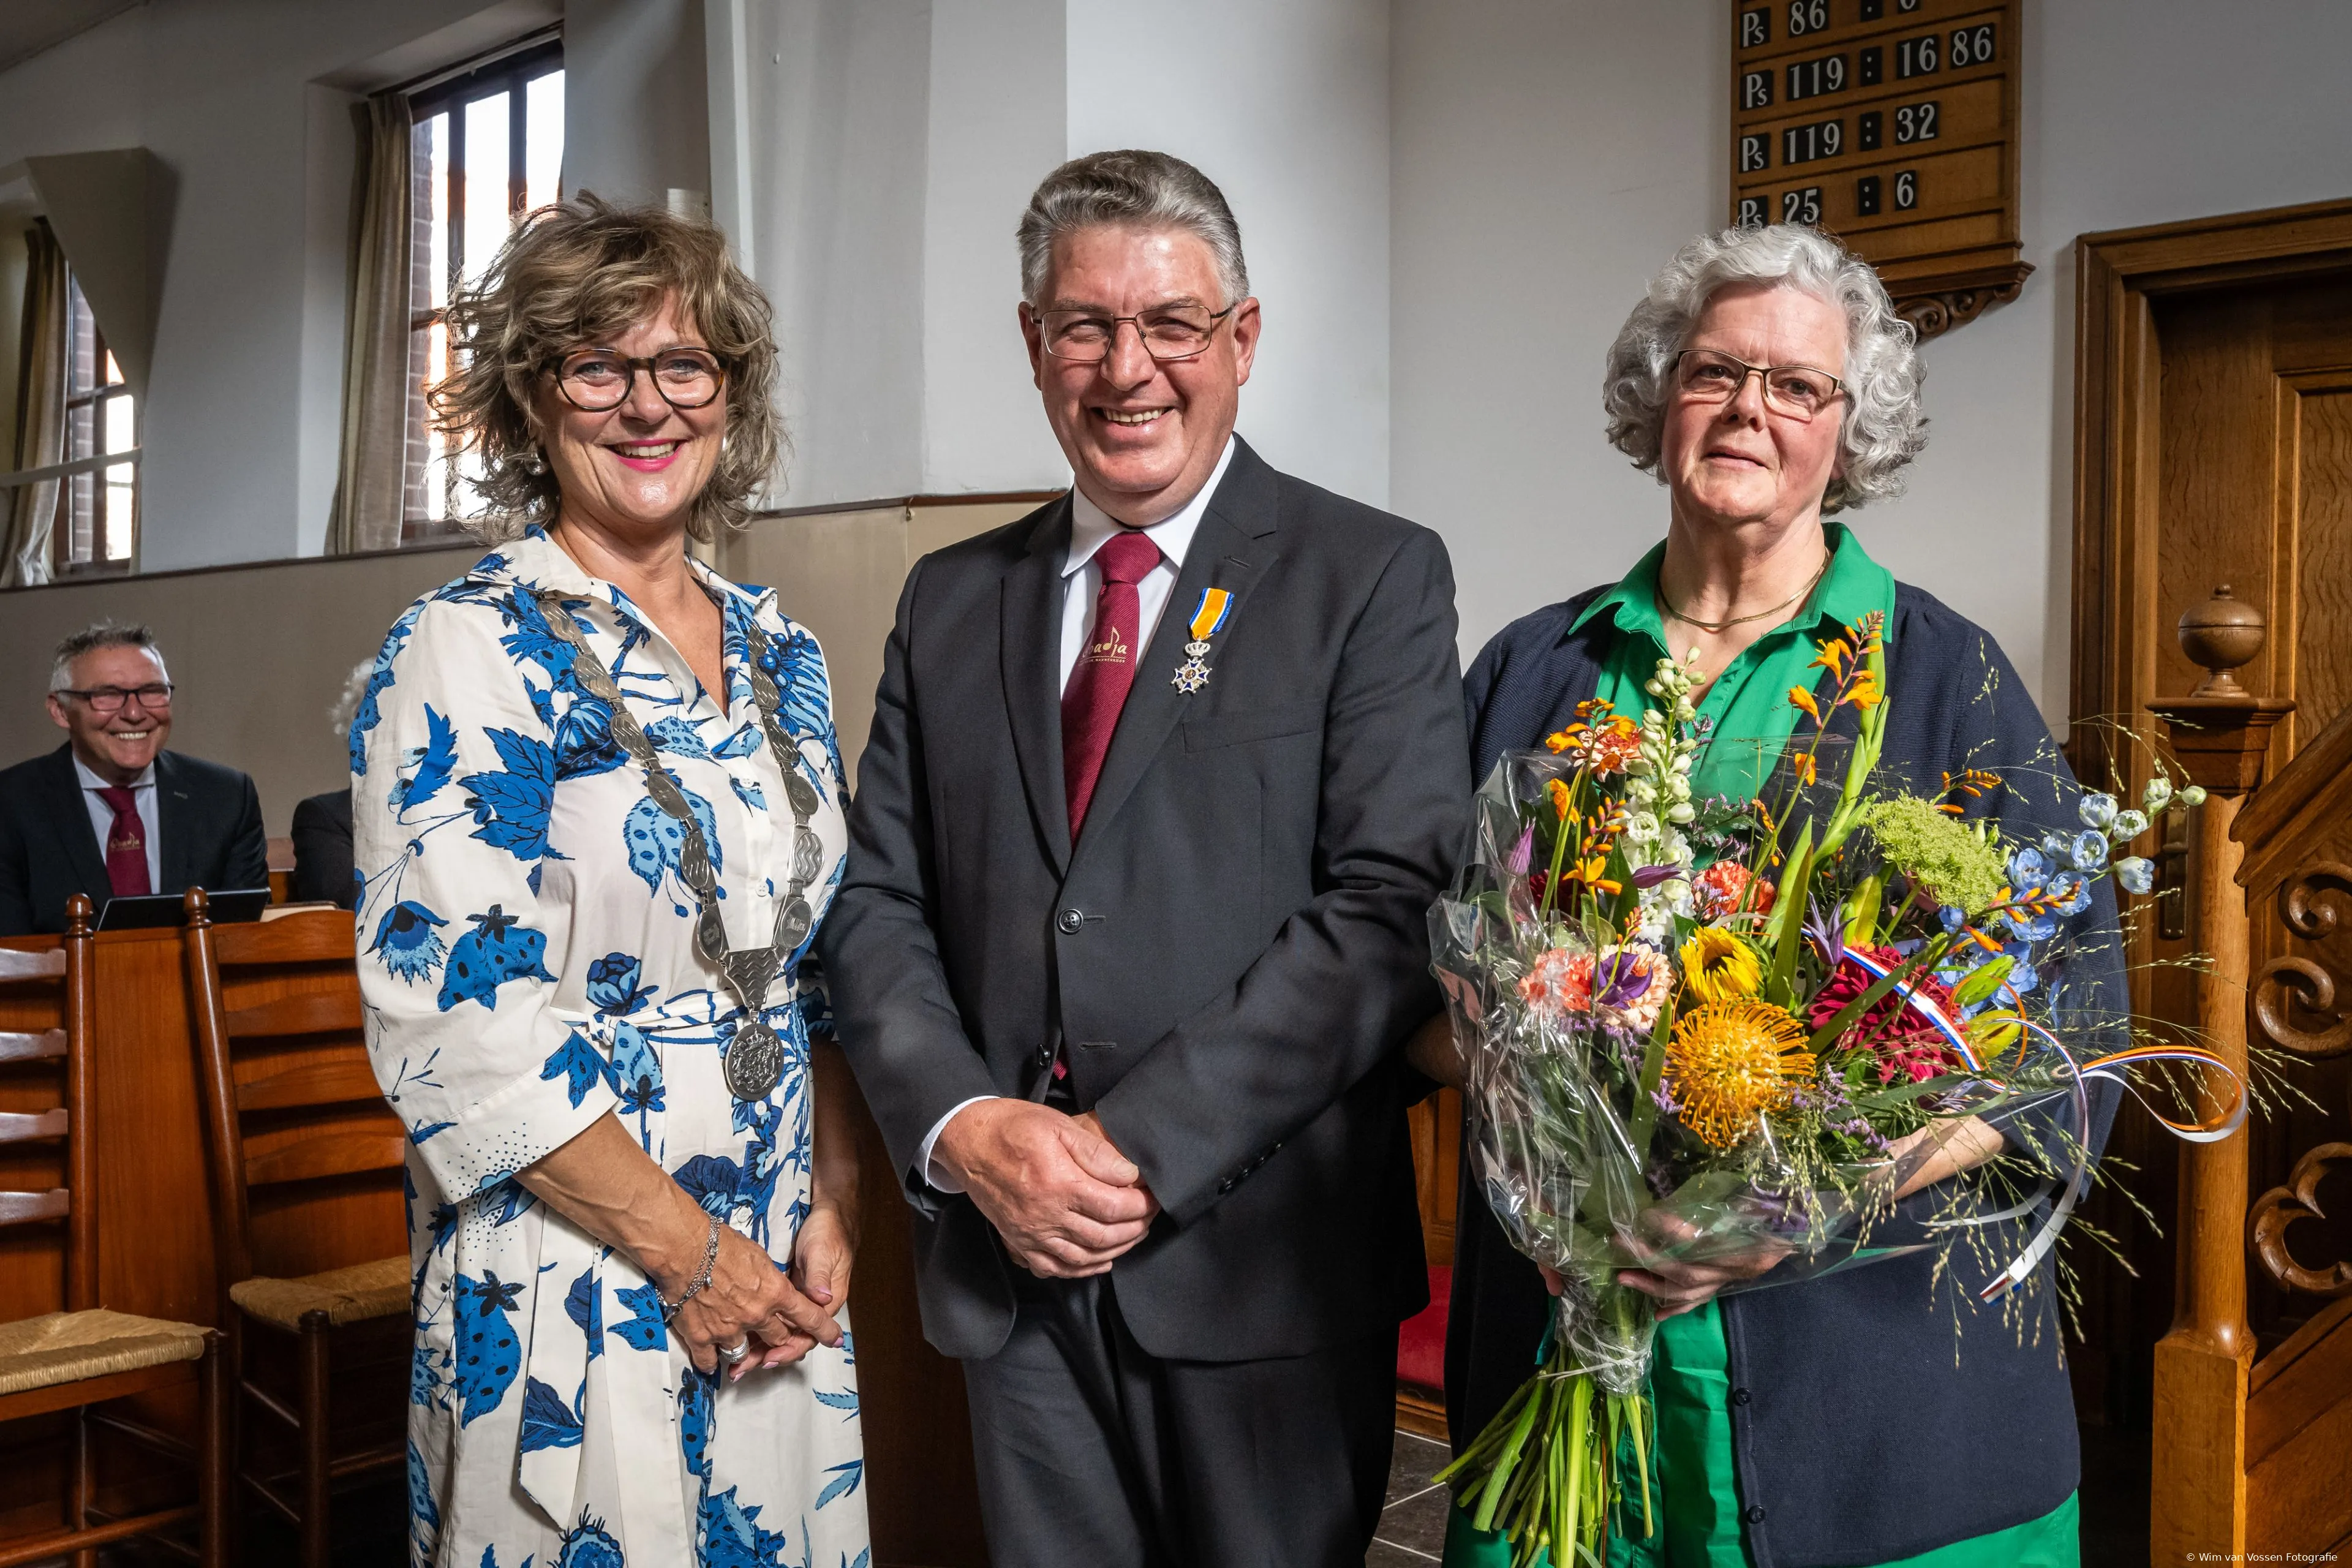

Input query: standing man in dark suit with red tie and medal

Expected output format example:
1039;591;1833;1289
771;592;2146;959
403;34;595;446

821;153;1470;1568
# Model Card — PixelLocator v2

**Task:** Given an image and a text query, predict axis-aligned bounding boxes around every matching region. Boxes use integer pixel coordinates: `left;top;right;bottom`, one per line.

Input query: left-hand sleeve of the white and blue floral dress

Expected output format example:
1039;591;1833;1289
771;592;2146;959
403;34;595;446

350;600;619;1201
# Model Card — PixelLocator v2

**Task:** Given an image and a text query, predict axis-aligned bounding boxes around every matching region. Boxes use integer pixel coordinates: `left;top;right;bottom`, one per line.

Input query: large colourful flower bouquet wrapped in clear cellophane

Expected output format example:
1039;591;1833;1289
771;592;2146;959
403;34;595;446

1430;616;2244;1568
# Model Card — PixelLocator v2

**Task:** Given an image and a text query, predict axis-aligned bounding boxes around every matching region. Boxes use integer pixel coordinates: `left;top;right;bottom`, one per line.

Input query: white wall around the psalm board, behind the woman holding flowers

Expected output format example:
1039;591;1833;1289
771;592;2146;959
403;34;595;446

1392;0;2352;719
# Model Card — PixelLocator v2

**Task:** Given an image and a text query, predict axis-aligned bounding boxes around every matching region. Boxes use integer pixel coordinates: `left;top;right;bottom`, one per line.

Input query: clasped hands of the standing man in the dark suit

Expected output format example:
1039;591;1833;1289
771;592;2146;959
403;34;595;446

932;1100;1159;1279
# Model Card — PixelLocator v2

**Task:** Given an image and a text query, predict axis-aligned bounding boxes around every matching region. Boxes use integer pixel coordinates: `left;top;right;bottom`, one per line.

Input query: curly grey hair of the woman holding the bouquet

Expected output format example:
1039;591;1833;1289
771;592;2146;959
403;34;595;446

1602;224;1926;513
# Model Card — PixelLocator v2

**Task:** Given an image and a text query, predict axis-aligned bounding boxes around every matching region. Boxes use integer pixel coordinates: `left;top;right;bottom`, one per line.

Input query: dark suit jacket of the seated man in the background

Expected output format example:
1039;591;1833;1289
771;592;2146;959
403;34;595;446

0;743;271;936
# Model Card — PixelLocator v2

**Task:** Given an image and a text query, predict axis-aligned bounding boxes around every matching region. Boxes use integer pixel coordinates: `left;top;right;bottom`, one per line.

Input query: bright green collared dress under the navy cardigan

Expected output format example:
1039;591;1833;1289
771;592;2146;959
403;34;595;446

1444;522;2079;1568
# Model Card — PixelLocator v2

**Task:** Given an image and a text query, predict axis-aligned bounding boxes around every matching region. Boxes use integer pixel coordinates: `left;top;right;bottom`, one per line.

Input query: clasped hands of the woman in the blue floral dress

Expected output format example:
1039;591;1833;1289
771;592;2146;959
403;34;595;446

658;1208;849;1380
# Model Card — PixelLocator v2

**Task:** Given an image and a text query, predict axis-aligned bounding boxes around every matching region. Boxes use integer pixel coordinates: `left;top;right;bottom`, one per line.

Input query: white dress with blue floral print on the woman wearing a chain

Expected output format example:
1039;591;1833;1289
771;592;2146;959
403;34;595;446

350;529;868;1568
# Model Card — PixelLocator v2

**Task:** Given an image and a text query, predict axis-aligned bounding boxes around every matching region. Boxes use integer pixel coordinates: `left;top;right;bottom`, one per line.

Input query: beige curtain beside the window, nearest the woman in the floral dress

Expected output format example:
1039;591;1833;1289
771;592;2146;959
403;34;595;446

327;92;412;555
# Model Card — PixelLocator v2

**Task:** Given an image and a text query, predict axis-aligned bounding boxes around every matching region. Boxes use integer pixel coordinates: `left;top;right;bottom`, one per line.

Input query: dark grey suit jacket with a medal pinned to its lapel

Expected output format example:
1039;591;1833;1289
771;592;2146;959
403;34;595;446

818;444;1470;1361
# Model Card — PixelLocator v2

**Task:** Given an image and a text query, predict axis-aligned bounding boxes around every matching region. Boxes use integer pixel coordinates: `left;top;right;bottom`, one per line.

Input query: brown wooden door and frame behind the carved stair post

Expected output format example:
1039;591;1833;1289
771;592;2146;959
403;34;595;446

2070;202;2352;1549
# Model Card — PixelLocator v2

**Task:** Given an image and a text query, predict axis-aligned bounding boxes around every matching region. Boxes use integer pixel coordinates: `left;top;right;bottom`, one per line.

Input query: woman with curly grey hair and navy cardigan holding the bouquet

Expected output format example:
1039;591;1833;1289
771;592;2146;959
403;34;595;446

1411;225;2124;1568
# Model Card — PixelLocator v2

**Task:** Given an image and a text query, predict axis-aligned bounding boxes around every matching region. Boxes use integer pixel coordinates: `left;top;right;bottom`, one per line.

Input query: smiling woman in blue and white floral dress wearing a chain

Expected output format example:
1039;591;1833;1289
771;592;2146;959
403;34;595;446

350;197;868;1568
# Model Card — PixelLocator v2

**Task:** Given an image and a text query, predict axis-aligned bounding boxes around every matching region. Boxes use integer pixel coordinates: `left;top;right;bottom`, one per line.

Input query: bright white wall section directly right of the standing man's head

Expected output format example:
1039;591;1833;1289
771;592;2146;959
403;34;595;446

1072;0;1392;505
